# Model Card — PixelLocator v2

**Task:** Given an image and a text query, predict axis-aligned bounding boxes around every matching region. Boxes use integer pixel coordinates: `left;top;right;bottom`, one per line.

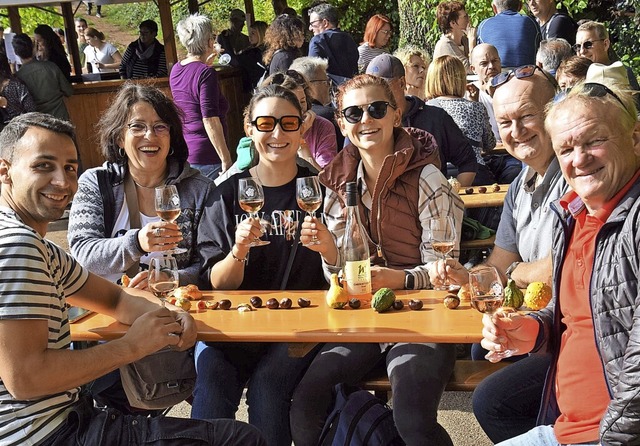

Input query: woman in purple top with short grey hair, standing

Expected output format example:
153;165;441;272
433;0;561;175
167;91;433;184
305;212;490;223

169;14;233;179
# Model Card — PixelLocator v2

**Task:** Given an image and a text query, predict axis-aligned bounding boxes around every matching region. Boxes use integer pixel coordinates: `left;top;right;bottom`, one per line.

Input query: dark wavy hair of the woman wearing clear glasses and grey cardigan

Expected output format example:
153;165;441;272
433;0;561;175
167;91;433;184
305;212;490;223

97;82;188;163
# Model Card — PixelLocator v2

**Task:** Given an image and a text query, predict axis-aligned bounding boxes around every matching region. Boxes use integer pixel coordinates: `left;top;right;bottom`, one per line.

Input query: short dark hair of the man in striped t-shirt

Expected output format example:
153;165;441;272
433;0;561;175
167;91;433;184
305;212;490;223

0;112;76;162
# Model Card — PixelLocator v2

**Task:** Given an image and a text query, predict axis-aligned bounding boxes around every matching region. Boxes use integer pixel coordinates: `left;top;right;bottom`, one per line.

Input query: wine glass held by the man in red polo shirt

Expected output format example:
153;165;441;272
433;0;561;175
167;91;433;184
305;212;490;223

469;266;518;362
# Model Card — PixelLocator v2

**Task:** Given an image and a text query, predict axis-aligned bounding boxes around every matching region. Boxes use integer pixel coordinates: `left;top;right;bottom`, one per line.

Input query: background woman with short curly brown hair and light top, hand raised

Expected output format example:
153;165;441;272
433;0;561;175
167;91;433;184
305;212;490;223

433;1;476;74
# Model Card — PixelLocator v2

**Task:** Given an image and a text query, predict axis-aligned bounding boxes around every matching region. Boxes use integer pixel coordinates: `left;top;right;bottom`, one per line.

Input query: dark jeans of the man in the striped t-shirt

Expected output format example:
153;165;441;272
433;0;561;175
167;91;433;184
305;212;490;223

42;396;267;446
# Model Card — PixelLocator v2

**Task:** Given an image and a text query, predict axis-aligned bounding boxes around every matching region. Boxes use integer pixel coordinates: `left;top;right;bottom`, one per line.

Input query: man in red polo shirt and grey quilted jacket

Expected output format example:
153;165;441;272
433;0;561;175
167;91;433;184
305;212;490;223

482;83;640;446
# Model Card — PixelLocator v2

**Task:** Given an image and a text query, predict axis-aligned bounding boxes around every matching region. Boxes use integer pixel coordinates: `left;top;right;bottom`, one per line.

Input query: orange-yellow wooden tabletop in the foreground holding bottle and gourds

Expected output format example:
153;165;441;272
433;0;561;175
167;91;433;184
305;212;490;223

71;290;482;343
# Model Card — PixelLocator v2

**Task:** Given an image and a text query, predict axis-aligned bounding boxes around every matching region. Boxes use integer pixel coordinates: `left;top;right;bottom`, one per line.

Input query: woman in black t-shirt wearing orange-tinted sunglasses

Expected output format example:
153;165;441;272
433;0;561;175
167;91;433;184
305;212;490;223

191;85;326;446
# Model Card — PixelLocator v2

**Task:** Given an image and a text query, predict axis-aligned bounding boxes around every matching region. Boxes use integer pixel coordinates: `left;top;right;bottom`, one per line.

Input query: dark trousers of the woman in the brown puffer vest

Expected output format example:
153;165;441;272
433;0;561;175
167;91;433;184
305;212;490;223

291;344;455;446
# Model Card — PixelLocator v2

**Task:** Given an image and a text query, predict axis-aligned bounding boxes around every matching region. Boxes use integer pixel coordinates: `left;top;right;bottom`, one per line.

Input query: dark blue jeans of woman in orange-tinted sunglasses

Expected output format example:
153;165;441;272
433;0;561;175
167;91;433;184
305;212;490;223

191;342;319;446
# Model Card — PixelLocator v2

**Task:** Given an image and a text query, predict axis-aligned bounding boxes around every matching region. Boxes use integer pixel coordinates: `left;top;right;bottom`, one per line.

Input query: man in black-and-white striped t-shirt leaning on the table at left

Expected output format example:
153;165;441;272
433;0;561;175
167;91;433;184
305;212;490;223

0;113;265;446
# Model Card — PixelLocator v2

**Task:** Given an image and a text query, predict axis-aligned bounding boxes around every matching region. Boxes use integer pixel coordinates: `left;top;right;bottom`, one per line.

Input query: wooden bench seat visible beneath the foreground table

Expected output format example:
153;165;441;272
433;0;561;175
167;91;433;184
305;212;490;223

358;359;510;401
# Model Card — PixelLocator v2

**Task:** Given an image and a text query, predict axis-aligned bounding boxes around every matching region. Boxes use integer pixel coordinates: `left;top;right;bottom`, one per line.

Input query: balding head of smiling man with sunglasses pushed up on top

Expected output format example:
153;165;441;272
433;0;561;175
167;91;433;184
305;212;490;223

493;70;556;175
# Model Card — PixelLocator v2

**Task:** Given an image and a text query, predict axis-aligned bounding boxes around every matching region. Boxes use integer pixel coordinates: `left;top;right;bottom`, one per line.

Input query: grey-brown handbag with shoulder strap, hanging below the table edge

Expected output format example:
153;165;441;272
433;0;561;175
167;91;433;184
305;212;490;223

120;175;196;409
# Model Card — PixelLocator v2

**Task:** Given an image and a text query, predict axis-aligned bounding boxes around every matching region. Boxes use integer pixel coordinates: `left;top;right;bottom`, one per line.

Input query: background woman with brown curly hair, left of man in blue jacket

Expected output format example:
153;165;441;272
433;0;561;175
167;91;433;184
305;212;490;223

263;14;304;75
